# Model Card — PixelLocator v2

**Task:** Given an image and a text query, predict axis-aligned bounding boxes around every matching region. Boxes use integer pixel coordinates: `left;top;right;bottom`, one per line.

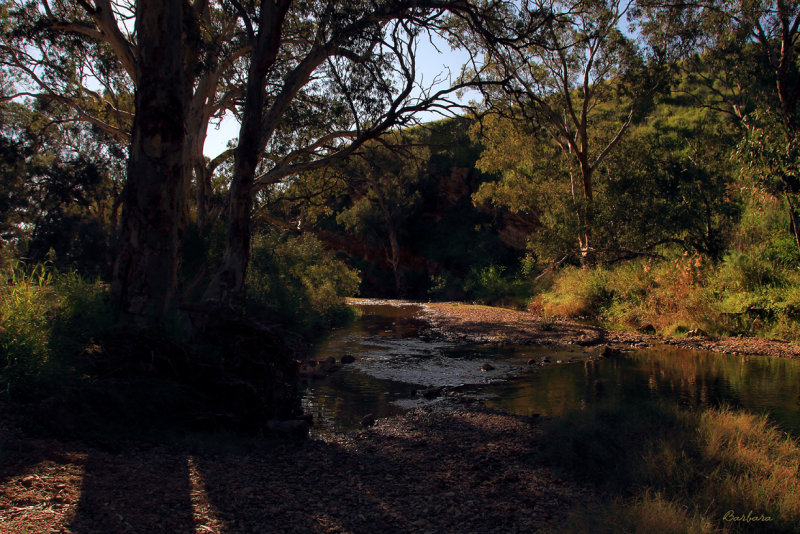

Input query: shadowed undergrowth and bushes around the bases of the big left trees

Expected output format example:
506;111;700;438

0;245;358;442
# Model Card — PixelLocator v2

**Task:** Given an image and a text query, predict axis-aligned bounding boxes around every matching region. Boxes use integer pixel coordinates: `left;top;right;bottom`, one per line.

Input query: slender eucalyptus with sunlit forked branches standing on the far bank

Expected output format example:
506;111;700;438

460;0;666;262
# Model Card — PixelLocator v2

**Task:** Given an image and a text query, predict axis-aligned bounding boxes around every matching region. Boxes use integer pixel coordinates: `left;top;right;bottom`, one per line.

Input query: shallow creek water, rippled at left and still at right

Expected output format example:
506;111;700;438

302;301;800;436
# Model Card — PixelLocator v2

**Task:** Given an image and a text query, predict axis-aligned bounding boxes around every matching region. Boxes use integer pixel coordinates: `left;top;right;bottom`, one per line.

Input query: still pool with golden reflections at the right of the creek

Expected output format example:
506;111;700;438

487;346;800;435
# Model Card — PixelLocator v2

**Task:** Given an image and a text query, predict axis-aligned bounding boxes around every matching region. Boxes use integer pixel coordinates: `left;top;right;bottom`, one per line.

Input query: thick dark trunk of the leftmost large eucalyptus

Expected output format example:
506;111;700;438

112;0;186;326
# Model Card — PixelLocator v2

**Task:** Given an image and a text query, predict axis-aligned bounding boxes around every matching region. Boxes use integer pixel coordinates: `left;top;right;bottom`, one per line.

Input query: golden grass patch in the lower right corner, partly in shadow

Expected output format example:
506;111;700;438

543;407;800;533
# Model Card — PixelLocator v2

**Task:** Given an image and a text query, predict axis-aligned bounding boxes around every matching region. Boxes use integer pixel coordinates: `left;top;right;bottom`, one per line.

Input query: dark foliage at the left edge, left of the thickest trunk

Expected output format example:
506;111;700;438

0;102;124;277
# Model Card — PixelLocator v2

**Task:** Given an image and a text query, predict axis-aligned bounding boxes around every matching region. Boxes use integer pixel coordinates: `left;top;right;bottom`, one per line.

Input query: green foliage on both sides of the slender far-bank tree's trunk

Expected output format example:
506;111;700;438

472;69;739;268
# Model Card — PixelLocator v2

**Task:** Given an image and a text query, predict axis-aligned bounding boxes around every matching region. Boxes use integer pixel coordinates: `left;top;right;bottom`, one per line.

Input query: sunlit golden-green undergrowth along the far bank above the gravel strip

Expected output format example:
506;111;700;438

532;252;800;342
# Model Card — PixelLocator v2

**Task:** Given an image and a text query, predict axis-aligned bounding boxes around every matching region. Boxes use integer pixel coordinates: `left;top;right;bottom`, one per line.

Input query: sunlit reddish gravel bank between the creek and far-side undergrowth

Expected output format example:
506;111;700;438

424;302;800;358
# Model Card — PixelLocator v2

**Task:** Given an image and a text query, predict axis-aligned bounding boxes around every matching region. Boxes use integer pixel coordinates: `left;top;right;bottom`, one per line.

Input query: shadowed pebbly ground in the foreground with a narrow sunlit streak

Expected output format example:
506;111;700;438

1;409;591;533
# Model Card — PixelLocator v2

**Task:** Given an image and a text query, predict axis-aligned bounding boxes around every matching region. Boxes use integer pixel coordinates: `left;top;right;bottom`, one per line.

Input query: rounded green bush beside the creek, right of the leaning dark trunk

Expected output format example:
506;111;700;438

247;231;359;331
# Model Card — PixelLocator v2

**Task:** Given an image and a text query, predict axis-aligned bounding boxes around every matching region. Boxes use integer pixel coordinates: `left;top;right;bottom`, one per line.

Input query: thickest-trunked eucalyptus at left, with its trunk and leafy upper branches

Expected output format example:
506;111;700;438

0;0;252;320
